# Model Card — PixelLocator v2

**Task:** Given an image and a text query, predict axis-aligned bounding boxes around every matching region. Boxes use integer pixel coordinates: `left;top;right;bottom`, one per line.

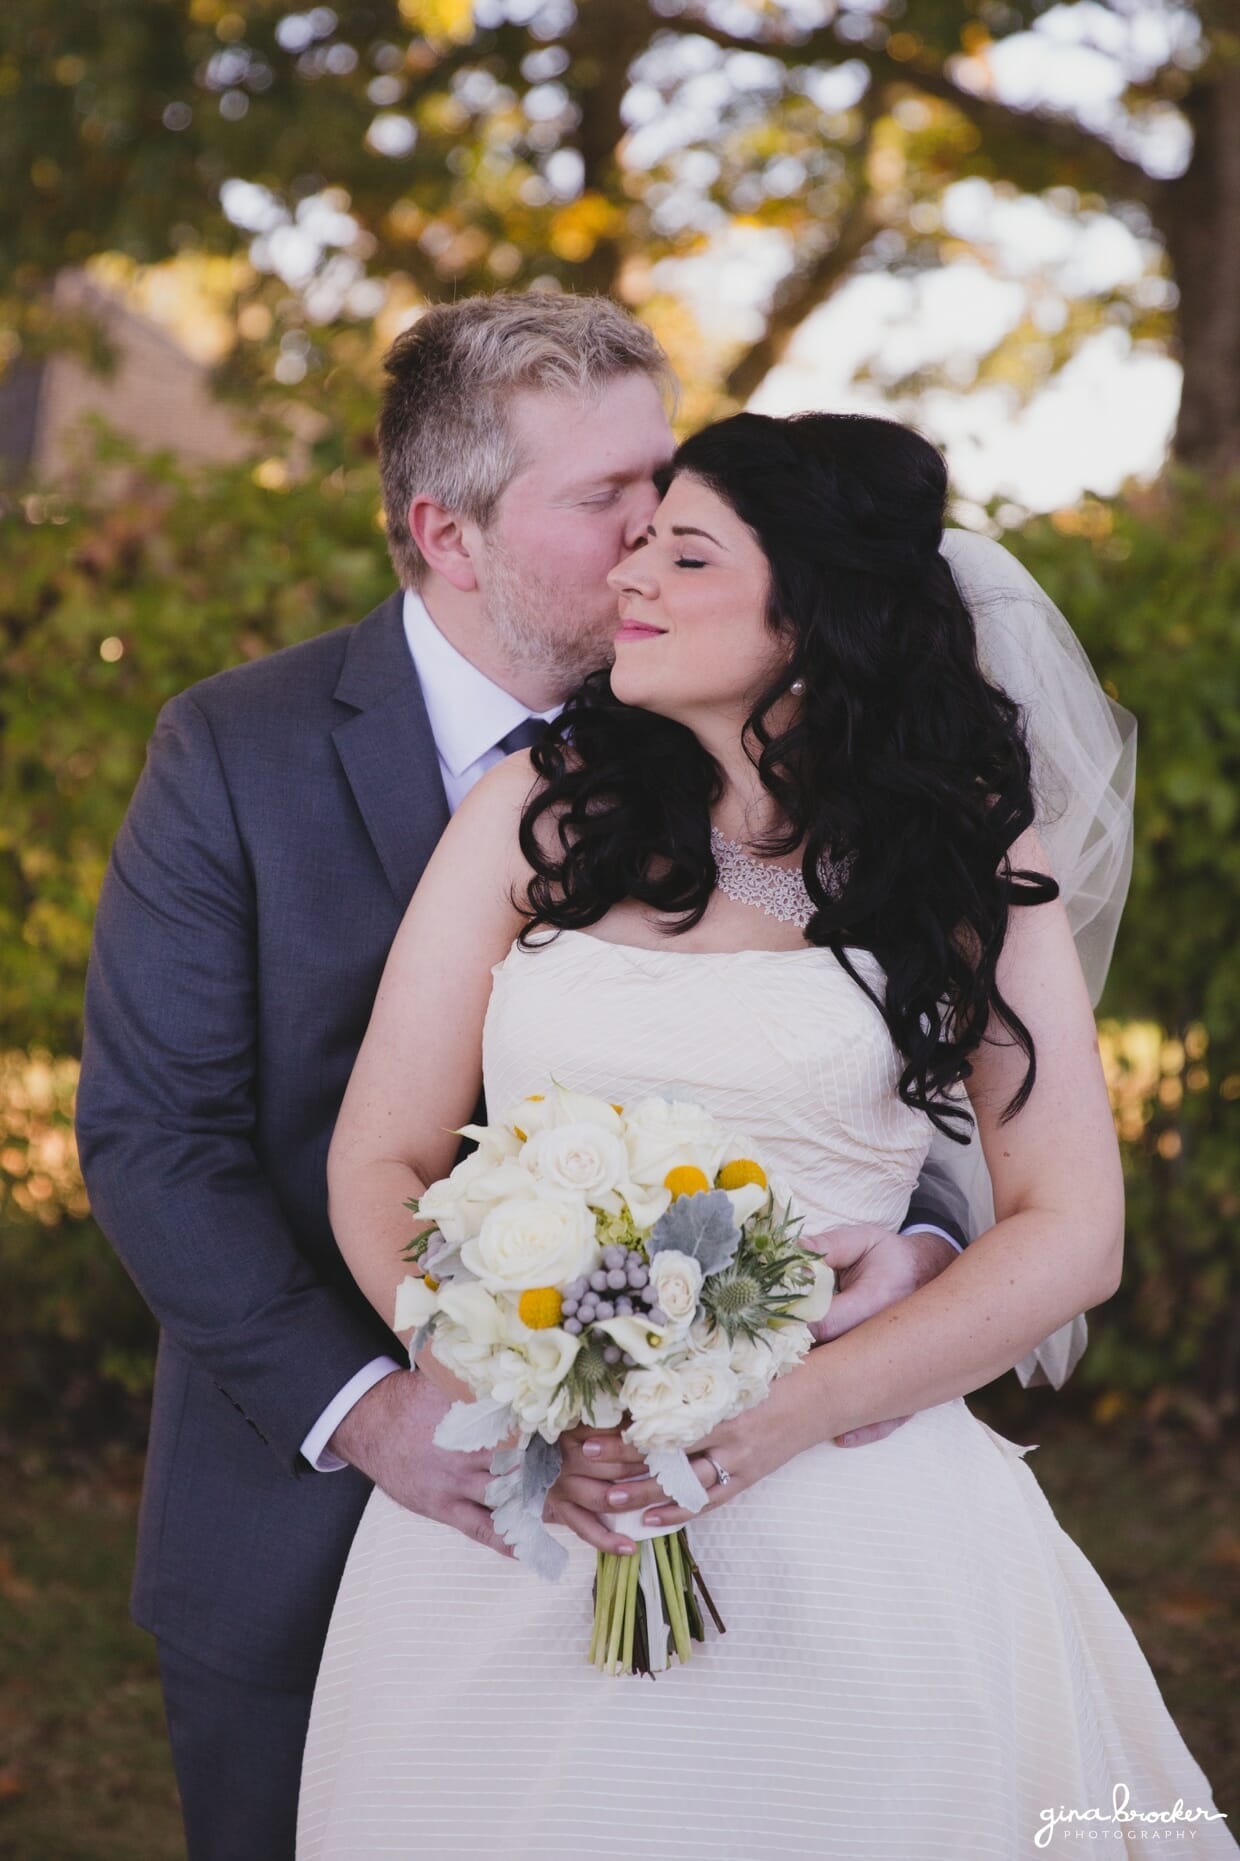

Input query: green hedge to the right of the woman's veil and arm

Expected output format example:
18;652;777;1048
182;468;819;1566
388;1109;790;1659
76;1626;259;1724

1007;476;1240;1401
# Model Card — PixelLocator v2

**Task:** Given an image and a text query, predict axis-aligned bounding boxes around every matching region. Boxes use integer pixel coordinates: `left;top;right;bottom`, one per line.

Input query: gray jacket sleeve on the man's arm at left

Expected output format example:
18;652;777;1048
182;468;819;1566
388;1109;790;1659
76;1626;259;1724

78;696;384;1470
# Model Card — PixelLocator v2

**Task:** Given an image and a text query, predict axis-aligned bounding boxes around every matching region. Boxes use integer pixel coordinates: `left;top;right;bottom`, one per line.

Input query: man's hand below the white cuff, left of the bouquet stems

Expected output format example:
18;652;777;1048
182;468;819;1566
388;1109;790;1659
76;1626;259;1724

330;1370;512;1558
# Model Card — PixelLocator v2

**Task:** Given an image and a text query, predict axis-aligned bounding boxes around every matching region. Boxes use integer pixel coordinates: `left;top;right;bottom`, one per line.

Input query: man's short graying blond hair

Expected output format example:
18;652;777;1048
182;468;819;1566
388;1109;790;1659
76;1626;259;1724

378;290;676;588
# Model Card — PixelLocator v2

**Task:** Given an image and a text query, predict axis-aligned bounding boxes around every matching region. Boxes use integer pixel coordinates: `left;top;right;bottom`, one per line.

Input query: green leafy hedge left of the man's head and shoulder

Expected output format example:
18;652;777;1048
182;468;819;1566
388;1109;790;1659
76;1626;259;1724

0;426;393;1053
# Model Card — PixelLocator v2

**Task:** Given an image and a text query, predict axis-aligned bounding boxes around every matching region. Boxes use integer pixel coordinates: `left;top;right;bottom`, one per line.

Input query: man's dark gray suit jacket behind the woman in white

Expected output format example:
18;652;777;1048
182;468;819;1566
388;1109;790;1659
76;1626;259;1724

78;596;975;1688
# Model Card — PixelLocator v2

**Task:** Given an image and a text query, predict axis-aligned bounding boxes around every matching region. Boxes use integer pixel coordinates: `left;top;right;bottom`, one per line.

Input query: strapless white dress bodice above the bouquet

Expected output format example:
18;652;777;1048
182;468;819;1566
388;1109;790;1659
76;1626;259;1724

482;931;931;1232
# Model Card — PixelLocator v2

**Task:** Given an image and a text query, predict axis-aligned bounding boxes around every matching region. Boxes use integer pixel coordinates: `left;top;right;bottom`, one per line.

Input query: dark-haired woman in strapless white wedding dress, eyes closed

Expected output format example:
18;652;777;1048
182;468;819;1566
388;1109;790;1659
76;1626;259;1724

298;415;1238;1861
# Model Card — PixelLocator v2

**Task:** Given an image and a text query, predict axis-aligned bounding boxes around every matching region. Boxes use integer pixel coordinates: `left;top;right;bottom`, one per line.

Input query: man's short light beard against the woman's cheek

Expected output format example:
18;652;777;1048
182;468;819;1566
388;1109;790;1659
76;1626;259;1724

482;543;620;696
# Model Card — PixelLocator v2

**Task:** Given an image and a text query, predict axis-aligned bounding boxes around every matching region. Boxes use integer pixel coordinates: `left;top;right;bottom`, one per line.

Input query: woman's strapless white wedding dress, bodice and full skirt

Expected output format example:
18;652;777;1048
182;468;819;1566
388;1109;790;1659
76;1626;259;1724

298;932;1240;1861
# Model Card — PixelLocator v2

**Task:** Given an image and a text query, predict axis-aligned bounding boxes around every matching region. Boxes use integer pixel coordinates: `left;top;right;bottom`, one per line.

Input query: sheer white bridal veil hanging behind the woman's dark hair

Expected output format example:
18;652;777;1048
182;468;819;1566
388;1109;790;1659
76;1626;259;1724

923;530;1136;1388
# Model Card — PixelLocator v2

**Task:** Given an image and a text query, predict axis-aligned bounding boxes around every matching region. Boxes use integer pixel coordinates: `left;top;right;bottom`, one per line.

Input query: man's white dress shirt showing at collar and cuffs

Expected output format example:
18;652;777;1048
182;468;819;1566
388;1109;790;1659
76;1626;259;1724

302;588;961;1474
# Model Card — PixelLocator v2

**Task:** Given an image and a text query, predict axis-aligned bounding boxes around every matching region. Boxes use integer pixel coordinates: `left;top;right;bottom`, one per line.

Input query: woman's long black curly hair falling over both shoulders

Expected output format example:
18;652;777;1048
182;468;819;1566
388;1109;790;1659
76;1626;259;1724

521;413;1059;1143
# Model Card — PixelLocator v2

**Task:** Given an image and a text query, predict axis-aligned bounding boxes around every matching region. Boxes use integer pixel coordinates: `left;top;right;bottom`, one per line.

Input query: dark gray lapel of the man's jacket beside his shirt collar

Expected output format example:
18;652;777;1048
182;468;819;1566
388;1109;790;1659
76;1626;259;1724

331;594;449;910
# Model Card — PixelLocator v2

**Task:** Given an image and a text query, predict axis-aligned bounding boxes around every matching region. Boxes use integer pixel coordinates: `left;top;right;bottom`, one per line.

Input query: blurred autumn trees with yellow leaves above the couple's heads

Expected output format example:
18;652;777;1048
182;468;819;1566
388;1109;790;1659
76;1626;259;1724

0;0;1240;446
